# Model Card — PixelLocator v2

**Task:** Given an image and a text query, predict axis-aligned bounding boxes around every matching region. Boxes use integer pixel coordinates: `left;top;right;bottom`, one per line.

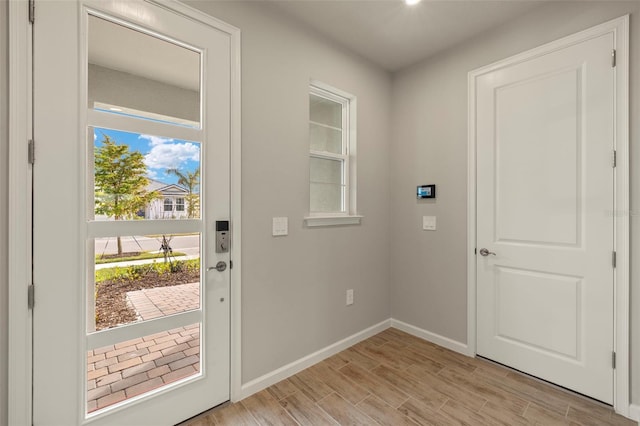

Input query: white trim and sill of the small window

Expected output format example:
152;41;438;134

304;80;363;227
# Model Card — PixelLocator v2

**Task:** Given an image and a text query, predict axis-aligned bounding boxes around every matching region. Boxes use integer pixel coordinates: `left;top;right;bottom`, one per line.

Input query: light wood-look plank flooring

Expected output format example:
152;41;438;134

185;328;636;426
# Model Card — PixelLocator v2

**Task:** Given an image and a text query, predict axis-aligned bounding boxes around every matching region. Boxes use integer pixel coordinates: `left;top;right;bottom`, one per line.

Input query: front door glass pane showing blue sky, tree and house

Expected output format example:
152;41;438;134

90;127;201;220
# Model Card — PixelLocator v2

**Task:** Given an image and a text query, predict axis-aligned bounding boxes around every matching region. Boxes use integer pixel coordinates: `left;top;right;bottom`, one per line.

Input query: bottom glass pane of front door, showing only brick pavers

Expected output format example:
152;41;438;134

86;323;201;413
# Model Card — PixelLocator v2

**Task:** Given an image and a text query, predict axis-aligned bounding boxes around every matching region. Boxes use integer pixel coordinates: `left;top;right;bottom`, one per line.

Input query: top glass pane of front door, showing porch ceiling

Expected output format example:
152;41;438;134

87;15;200;127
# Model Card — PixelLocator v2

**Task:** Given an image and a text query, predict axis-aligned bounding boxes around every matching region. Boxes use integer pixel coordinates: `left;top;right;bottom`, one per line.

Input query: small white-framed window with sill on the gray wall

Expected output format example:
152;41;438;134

306;83;359;226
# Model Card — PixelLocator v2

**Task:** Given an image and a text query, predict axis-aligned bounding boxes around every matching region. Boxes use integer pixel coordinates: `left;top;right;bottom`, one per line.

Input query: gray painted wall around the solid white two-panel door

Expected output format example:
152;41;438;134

391;1;640;403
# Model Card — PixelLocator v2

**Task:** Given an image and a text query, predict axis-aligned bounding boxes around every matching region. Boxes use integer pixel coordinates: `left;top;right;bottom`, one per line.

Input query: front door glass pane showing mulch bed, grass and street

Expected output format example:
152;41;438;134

88;233;200;331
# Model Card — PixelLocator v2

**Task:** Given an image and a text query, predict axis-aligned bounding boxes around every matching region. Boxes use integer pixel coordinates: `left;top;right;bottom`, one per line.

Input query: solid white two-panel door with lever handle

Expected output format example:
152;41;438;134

476;34;615;403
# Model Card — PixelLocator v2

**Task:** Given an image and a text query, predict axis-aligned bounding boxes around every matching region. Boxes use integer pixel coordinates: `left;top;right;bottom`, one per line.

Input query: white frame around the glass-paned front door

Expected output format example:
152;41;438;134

8;0;242;424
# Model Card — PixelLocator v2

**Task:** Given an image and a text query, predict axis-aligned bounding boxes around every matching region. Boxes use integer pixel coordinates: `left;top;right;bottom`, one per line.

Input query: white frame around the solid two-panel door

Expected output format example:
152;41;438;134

467;15;630;417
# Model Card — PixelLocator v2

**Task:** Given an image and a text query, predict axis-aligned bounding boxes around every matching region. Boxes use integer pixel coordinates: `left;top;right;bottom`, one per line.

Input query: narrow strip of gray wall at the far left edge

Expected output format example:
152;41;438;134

0;2;9;425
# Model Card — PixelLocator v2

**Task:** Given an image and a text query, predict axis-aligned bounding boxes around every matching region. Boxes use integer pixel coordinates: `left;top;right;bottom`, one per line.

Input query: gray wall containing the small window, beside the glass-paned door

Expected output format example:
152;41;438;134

185;1;391;383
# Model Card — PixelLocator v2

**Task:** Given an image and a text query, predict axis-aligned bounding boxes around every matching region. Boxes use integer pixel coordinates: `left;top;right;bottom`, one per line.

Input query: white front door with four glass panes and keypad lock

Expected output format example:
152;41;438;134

33;0;232;425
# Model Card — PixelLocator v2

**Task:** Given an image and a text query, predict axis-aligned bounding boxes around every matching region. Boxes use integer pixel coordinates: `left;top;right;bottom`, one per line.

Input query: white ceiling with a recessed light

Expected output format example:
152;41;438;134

265;0;541;71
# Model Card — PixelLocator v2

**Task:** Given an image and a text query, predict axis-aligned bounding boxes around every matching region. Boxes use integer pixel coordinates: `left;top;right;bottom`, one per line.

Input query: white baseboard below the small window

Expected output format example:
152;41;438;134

234;319;392;402
